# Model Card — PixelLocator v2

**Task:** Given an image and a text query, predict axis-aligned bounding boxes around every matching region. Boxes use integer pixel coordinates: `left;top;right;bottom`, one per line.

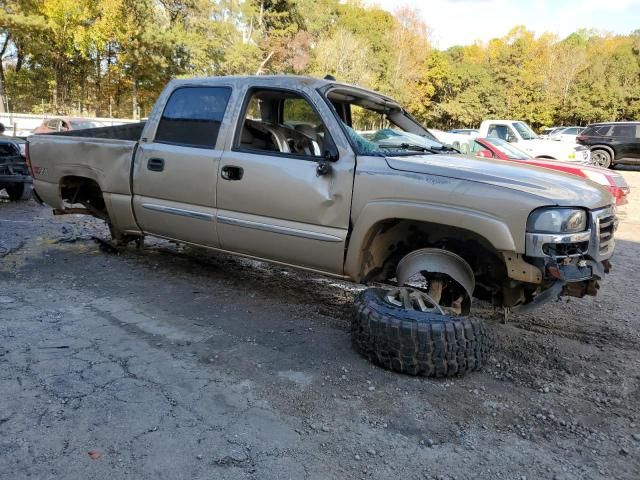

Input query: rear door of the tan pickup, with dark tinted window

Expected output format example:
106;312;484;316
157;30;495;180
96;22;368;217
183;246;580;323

133;86;231;247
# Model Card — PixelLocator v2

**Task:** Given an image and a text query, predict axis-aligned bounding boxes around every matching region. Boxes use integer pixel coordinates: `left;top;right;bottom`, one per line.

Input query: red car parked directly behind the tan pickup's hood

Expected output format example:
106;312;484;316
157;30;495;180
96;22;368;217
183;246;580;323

469;138;631;205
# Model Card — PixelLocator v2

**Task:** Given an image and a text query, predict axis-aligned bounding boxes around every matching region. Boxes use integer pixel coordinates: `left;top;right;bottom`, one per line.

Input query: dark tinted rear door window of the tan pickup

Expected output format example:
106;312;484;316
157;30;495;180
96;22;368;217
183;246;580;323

155;87;231;148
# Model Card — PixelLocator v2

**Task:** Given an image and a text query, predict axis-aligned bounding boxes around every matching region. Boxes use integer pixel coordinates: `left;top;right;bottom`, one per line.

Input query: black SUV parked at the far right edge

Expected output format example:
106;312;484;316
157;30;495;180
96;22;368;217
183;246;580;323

576;122;640;168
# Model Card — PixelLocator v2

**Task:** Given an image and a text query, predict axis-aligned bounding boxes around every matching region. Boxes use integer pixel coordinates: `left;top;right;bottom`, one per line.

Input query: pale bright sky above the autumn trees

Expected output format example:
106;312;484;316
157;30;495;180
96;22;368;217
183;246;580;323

367;0;640;49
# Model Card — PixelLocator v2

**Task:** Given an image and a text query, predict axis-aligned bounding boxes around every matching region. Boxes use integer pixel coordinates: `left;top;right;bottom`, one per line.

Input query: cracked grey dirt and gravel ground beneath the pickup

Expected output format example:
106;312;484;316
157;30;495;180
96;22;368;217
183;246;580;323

0;171;640;480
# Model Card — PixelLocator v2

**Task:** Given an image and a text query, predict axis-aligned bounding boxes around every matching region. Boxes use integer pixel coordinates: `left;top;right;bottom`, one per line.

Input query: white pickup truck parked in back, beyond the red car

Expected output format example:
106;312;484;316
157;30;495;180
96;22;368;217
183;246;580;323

478;120;591;164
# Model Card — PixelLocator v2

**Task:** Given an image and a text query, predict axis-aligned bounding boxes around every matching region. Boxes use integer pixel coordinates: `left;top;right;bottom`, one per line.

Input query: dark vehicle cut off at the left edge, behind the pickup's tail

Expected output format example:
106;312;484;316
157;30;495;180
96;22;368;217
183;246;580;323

0;136;32;201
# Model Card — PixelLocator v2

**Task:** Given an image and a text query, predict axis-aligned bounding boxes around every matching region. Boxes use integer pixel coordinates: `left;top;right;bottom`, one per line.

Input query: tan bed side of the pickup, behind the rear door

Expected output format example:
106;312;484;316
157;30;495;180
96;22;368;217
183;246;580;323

28;123;144;208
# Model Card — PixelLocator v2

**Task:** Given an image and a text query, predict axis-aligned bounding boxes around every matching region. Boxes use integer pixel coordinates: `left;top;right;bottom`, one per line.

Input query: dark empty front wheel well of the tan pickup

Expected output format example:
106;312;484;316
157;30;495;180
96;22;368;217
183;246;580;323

360;219;508;296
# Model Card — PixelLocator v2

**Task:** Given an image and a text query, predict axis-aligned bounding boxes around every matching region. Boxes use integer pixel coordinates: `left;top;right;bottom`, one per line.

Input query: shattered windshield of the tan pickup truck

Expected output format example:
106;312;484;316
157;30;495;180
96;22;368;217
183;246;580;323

327;90;454;157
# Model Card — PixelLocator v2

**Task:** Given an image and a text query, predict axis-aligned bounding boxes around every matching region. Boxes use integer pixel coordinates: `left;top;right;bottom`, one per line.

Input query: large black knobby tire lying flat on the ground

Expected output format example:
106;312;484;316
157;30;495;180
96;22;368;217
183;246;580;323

351;288;490;377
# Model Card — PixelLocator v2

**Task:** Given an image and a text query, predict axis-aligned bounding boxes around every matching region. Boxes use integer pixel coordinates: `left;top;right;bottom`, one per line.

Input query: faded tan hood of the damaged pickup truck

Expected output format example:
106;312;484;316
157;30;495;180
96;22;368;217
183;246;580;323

386;154;613;209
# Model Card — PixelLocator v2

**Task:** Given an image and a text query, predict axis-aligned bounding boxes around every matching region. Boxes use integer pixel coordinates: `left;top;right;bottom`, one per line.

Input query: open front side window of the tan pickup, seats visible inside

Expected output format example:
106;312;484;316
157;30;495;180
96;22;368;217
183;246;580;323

235;89;327;157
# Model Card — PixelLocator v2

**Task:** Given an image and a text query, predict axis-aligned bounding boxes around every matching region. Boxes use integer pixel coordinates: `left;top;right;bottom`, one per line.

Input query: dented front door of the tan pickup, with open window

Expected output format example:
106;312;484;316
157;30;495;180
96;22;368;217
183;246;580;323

217;86;355;273
